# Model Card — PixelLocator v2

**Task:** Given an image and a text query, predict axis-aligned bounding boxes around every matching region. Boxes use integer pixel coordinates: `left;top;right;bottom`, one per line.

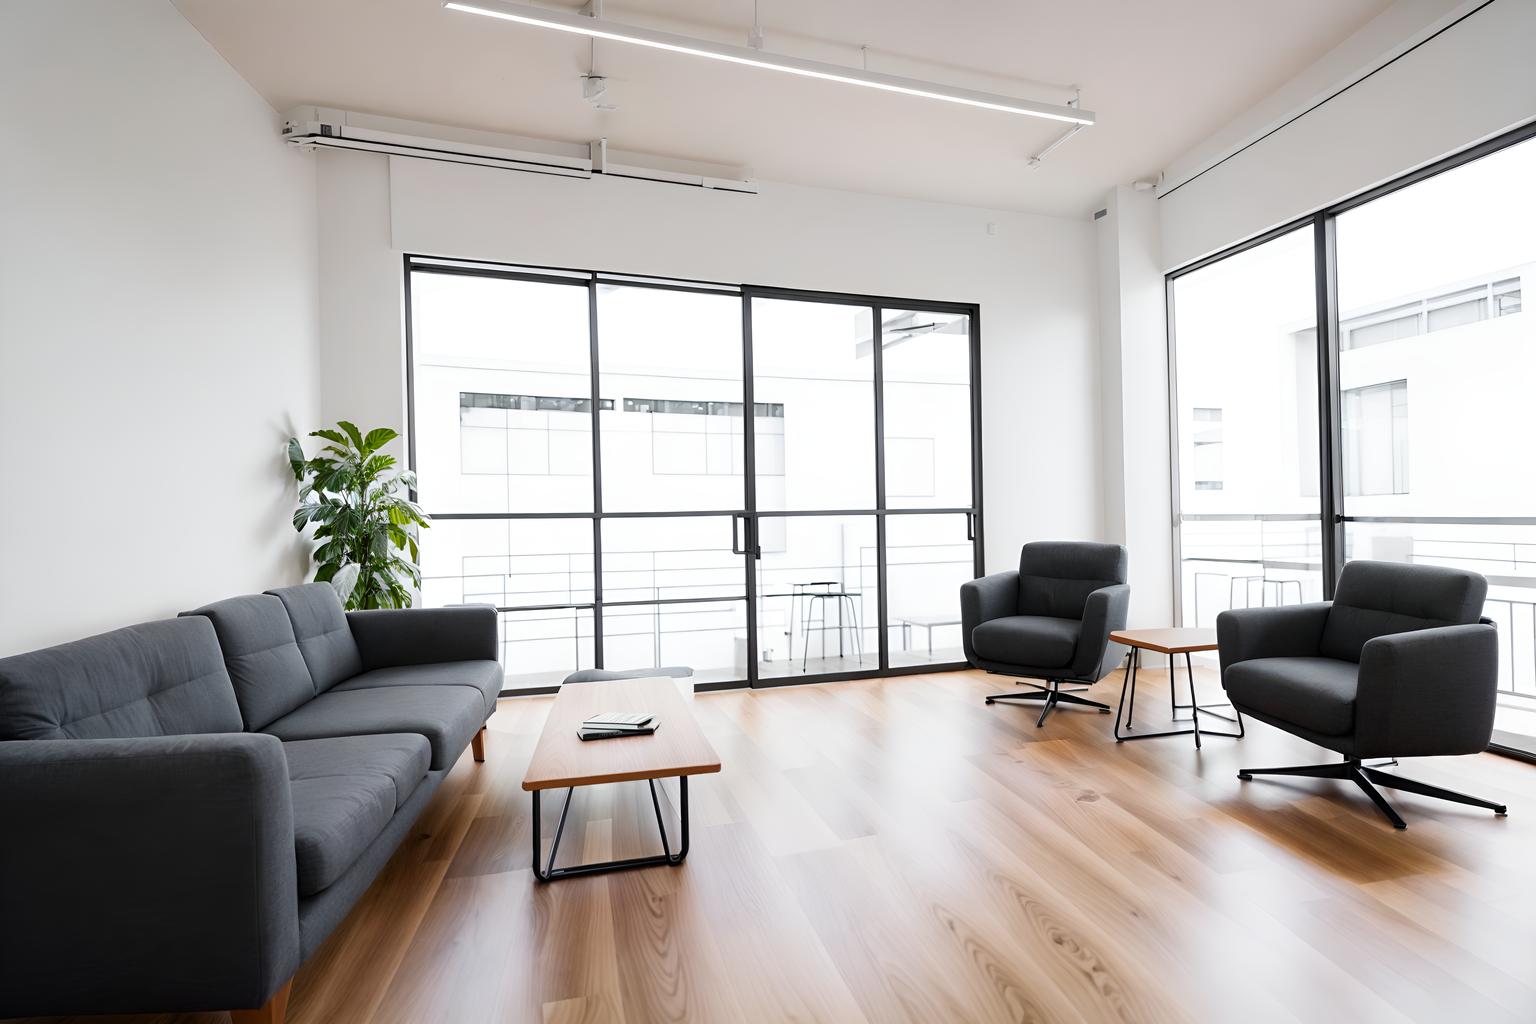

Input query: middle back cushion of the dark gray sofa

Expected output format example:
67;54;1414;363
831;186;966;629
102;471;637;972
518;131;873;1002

181;594;315;732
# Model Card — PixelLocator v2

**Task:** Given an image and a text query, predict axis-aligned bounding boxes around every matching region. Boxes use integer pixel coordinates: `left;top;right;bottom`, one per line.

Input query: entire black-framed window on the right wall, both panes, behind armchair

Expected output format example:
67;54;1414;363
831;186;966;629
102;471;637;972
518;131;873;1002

1169;127;1536;749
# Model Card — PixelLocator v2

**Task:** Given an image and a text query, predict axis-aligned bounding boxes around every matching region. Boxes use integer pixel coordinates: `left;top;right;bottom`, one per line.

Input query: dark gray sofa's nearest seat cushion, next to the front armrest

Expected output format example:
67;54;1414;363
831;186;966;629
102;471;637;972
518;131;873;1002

283;734;432;897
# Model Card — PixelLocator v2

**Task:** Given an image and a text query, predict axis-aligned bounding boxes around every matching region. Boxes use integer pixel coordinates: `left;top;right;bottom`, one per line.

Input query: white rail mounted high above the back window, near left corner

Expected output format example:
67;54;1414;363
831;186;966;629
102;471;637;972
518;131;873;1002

283;106;757;193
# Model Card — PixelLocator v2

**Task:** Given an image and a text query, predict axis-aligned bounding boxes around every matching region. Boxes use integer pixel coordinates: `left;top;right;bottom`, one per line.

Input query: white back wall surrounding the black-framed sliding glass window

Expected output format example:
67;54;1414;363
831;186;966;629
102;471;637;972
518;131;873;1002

319;154;1103;580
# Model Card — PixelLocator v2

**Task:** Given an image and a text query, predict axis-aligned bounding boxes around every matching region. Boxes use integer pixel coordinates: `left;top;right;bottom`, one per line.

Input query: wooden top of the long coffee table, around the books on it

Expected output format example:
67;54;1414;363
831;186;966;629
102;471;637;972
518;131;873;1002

522;677;720;791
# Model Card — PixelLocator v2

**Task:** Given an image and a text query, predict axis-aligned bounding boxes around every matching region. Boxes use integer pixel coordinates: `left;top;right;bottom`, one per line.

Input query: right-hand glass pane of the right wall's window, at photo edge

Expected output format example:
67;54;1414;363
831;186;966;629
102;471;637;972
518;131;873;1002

1336;132;1536;749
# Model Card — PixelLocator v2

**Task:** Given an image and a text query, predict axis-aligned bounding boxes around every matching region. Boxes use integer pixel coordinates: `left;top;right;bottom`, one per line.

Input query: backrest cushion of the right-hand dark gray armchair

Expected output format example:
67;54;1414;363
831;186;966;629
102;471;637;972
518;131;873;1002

1319;562;1488;662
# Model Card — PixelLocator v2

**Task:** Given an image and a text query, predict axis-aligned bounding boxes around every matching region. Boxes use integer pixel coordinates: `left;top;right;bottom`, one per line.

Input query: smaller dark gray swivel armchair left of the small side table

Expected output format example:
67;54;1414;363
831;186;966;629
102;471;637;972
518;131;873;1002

960;540;1130;726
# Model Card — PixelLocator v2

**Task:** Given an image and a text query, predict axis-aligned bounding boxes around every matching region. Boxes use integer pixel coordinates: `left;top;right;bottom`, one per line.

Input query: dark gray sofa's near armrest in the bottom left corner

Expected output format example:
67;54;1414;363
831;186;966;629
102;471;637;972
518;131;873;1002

0;732;300;1016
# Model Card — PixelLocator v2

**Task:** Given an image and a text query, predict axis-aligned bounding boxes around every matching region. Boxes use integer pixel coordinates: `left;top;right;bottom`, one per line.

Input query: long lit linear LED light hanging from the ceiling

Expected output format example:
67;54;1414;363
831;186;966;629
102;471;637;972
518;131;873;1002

442;0;1094;124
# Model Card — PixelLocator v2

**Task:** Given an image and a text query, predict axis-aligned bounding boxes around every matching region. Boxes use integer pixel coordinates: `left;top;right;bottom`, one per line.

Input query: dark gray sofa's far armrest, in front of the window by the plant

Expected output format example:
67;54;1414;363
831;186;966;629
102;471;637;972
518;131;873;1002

347;605;498;669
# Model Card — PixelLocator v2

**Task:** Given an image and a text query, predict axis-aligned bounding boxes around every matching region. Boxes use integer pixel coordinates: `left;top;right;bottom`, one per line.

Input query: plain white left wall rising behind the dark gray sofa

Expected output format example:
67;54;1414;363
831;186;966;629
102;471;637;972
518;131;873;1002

0;0;319;654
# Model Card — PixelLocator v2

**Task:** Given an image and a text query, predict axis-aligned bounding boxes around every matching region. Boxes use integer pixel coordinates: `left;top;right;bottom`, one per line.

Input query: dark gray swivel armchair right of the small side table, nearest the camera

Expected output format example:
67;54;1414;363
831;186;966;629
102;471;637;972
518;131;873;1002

1217;562;1505;829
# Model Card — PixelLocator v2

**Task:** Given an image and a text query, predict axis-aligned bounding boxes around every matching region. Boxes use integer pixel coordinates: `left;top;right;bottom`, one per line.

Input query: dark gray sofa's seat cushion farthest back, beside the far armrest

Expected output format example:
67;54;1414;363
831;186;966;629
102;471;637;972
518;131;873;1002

263;686;488;771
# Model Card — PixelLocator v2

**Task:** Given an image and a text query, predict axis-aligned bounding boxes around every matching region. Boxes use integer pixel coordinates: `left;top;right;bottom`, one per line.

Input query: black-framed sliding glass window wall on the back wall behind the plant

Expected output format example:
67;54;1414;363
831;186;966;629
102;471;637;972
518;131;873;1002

407;258;980;692
